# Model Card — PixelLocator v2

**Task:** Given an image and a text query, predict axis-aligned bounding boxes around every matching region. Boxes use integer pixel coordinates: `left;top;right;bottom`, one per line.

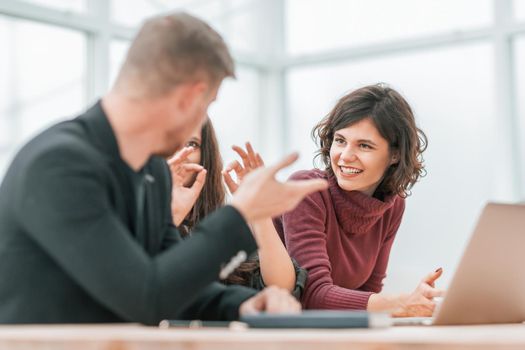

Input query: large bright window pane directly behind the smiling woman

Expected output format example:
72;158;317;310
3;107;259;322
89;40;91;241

287;44;496;291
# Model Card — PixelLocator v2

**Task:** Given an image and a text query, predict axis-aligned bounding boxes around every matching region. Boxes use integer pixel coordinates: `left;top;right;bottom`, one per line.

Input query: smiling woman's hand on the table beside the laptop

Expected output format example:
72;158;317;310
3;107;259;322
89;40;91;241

392;268;445;317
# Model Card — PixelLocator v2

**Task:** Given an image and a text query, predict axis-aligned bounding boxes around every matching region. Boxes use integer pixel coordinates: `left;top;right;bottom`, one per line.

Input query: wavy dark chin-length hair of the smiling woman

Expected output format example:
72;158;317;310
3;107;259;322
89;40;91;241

312;84;427;197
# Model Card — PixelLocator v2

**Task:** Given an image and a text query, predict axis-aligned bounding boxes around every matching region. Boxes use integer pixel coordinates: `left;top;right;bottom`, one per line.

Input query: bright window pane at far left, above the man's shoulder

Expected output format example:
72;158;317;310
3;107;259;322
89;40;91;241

0;16;86;178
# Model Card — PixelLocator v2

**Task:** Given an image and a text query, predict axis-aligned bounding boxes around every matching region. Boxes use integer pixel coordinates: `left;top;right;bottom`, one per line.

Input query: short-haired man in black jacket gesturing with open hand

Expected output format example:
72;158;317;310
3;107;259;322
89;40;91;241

0;13;326;324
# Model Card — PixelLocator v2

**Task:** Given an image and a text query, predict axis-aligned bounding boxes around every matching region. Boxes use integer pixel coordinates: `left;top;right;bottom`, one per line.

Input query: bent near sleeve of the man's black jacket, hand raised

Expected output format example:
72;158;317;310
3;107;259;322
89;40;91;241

14;149;256;324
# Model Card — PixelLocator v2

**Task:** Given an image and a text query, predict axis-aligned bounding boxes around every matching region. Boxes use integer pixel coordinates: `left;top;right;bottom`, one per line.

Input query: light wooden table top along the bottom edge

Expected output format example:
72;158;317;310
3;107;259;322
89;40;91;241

0;324;525;350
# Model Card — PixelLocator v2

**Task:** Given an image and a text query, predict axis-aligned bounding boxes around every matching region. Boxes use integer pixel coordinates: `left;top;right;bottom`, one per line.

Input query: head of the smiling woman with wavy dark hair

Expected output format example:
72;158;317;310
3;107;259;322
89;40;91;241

312;85;427;199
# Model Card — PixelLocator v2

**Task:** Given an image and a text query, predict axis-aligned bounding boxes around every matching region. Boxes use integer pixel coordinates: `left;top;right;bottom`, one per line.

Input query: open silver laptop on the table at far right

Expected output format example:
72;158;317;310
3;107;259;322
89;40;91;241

393;203;525;325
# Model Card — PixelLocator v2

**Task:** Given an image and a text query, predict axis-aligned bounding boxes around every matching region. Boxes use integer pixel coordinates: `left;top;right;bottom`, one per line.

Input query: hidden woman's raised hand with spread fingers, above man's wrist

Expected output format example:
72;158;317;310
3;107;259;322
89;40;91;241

222;142;264;194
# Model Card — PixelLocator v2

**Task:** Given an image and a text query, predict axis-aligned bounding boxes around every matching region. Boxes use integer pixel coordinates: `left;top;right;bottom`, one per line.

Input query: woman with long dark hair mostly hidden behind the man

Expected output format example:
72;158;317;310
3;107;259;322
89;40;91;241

168;118;306;298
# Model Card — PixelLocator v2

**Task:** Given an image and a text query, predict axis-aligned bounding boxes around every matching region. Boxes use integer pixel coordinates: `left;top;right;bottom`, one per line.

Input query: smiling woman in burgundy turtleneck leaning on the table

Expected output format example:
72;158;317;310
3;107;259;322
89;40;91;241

274;84;442;316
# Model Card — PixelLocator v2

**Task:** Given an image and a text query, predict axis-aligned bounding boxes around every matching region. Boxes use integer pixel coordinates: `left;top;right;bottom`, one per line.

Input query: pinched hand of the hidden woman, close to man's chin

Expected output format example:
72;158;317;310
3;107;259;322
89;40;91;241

168;147;206;226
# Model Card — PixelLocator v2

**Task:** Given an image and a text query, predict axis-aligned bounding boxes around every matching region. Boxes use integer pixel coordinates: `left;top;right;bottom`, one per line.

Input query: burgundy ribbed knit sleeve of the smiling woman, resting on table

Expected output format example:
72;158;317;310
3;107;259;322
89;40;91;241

283;193;372;310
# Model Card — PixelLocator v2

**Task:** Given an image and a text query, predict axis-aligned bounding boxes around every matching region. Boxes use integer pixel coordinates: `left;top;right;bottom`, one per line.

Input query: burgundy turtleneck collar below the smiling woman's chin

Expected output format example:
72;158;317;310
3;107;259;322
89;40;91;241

326;173;397;234
